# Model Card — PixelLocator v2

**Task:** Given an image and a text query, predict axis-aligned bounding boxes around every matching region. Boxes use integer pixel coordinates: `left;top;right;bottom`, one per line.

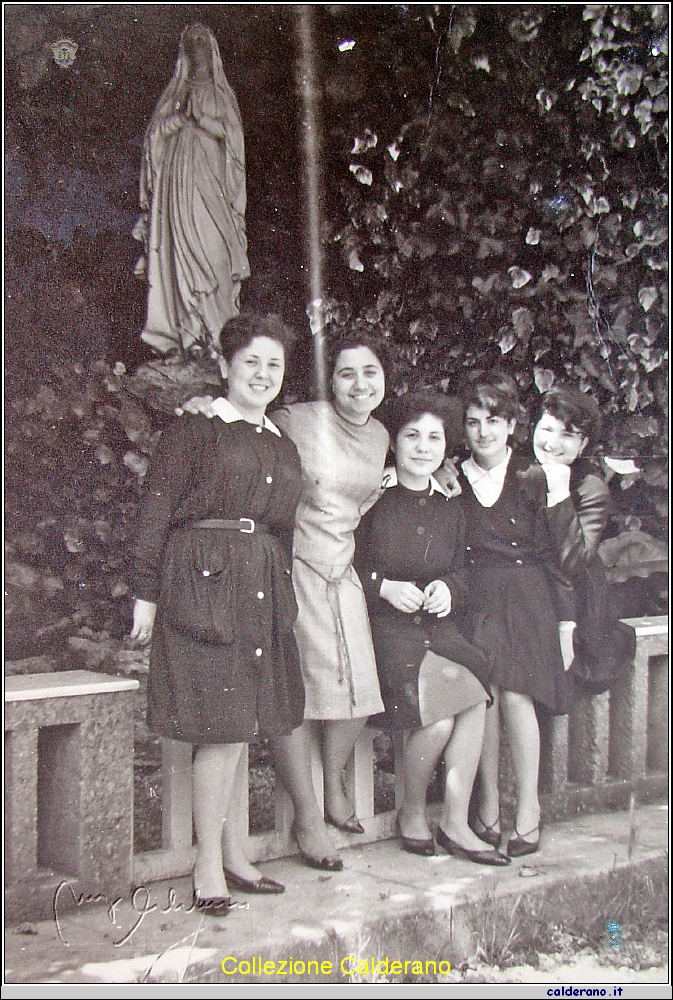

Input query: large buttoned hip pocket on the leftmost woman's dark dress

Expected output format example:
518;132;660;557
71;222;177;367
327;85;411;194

161;530;236;646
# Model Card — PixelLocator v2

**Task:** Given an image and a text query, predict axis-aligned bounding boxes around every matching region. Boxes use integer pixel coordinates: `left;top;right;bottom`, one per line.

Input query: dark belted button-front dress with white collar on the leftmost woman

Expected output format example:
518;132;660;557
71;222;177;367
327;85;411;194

134;398;304;744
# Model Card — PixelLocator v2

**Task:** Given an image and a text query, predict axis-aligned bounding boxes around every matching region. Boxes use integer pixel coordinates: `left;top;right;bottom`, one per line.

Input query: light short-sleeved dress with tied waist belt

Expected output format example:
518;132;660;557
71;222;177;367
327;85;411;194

273;402;388;719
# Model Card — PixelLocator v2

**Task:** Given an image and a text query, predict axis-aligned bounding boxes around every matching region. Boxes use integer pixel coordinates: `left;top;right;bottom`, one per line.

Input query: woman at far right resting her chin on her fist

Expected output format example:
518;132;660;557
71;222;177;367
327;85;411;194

524;387;635;693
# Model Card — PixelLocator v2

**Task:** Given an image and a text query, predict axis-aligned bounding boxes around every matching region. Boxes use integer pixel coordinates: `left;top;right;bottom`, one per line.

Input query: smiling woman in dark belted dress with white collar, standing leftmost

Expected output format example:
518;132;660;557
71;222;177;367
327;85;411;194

132;316;340;915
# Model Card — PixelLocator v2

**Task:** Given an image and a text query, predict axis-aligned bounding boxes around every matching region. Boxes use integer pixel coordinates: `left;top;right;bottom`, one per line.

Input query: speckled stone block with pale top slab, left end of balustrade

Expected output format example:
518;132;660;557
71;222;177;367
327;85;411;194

5;670;138;921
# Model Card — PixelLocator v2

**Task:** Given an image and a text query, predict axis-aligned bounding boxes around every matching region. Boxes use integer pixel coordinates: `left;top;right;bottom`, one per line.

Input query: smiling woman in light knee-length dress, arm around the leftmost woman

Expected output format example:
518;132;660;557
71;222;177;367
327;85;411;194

274;335;388;833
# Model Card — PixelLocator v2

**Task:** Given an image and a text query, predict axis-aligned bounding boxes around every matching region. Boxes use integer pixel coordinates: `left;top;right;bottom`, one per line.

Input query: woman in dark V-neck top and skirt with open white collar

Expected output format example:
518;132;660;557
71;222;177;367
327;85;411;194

461;378;567;857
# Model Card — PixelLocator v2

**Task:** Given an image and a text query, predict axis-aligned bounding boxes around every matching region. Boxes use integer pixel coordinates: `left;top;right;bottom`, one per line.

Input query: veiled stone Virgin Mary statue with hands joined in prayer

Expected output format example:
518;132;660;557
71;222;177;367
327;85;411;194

134;24;250;356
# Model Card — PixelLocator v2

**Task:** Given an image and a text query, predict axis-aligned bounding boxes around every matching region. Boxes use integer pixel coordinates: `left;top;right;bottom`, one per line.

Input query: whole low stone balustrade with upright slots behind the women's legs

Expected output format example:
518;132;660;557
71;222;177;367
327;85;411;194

5;617;668;920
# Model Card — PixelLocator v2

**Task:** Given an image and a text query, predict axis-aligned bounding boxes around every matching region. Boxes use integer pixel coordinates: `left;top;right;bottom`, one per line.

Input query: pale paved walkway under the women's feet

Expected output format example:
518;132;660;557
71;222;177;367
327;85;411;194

5;805;668;985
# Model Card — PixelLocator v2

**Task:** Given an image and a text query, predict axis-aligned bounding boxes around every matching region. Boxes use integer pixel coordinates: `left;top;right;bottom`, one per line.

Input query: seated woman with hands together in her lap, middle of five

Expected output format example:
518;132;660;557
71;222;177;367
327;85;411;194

356;393;507;865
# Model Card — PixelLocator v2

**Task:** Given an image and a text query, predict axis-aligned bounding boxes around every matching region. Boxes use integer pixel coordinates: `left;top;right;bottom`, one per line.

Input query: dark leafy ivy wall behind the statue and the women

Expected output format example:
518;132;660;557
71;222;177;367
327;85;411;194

5;4;668;658
